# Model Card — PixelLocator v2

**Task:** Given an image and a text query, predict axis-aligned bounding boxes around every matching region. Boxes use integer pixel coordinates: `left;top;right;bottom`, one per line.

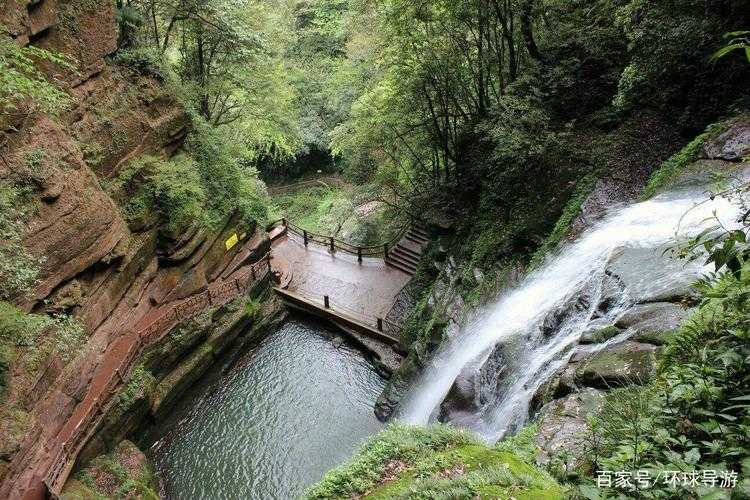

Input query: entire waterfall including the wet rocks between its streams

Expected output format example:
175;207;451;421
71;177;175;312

396;179;739;442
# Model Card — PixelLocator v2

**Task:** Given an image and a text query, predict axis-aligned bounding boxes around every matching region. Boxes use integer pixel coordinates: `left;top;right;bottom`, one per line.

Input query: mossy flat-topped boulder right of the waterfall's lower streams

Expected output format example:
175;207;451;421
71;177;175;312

575;342;658;389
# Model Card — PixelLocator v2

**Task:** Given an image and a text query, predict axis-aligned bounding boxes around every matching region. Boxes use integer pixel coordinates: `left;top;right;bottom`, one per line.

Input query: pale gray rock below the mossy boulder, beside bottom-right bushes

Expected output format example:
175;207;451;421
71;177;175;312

536;389;604;468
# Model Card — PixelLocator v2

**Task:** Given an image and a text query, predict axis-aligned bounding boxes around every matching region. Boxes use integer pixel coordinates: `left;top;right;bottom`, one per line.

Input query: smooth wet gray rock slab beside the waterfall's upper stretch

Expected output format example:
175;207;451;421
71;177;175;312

607;247;701;303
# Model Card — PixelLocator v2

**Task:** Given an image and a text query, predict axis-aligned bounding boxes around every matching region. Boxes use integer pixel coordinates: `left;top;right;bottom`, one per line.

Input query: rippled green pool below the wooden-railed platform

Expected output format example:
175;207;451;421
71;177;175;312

151;317;384;500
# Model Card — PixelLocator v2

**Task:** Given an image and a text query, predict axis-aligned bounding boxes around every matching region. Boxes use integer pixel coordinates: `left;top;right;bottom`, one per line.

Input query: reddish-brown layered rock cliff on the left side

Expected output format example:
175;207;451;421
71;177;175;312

0;0;267;487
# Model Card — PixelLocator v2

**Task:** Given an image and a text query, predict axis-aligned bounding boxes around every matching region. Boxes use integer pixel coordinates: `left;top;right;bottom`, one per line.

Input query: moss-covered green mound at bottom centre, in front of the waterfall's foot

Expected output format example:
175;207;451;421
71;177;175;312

306;425;562;499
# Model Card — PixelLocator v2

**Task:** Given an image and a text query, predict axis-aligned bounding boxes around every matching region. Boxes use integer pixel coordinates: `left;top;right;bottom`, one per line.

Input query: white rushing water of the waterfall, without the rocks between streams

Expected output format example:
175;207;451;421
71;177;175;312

396;179;738;442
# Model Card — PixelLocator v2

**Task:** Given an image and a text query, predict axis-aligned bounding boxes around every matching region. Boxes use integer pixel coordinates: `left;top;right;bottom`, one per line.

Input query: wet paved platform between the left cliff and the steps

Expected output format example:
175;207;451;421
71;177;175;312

271;233;411;318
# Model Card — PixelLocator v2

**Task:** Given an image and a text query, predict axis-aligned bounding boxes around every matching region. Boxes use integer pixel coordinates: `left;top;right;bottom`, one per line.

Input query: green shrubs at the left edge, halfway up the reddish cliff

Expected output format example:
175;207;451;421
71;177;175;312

0;182;40;300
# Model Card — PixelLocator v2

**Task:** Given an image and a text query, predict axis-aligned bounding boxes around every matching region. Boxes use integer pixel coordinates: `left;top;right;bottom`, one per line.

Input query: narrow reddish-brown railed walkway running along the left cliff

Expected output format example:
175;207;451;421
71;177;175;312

39;254;271;498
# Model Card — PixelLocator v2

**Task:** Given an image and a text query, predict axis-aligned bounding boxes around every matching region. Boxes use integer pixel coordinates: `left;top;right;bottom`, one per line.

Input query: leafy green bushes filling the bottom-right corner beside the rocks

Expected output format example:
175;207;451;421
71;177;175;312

568;236;750;498
